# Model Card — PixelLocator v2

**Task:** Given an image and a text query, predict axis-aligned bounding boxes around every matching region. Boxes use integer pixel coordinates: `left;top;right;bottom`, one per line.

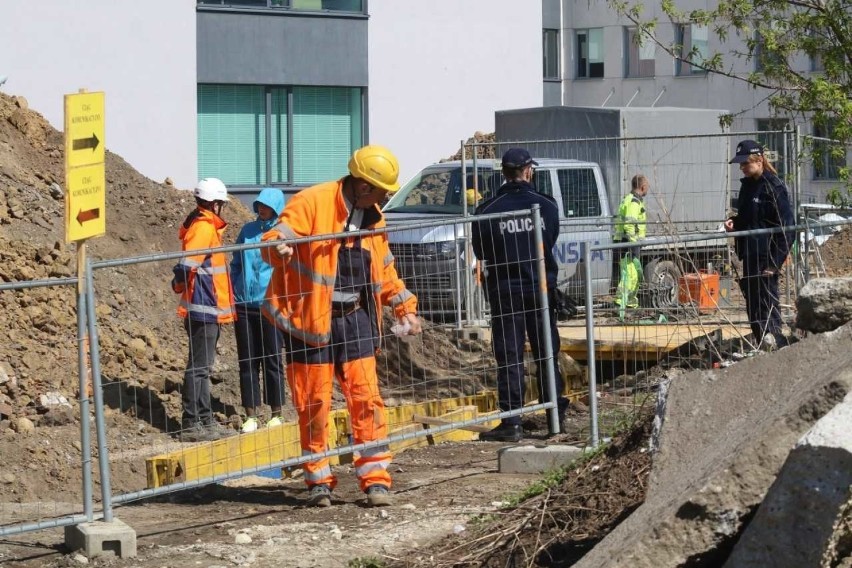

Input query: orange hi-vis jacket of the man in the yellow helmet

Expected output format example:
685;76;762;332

261;179;417;346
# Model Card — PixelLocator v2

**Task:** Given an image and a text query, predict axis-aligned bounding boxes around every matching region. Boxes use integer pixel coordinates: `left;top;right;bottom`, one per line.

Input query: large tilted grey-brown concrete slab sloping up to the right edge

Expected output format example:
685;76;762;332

574;324;852;568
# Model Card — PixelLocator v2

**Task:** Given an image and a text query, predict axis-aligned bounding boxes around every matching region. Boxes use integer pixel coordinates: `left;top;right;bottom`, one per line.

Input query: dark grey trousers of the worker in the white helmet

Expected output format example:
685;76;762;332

181;318;219;428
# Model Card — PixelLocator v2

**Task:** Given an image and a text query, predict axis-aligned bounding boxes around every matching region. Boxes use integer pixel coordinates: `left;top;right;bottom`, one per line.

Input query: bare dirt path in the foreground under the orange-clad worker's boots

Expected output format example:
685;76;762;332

0;442;536;568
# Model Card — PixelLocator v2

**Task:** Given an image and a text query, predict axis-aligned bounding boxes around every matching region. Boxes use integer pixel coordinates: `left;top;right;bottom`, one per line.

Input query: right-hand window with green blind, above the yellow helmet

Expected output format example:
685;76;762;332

293;87;361;183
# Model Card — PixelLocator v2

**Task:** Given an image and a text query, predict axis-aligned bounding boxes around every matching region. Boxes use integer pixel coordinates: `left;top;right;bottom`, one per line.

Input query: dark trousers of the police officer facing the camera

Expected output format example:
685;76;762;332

740;255;783;343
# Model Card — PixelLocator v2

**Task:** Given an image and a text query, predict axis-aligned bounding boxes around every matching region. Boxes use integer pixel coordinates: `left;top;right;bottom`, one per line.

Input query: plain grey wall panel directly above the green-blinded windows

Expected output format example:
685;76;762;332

198;9;368;87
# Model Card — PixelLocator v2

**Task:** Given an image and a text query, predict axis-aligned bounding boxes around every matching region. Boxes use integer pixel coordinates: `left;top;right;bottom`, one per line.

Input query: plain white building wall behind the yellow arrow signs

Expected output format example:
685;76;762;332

0;0;197;187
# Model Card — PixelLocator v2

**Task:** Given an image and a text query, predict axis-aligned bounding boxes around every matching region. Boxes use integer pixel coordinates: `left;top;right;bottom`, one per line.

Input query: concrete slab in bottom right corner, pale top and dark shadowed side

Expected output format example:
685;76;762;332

725;395;852;568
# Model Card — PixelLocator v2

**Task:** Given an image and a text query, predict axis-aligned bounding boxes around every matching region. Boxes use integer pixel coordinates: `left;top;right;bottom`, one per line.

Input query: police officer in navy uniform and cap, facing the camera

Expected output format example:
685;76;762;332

725;140;795;349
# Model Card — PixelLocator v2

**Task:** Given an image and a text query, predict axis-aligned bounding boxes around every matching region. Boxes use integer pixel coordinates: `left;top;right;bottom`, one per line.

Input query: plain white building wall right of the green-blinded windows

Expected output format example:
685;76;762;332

368;0;543;180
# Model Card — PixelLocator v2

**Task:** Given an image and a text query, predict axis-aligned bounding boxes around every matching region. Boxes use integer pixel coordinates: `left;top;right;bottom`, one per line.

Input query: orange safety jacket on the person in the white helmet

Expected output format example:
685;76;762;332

172;207;237;323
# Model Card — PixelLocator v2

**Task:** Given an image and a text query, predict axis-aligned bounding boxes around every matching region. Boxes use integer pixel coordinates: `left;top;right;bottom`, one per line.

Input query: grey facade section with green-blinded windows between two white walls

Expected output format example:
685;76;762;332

197;0;369;189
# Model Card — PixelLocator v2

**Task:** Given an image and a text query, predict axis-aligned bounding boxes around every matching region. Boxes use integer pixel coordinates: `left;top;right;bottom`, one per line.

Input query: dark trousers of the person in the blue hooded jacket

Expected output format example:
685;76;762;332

234;305;284;408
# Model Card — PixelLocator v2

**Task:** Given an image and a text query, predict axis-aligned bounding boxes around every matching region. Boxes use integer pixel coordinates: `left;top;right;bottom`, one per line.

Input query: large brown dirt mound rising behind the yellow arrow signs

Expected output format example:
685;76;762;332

0;93;493;506
